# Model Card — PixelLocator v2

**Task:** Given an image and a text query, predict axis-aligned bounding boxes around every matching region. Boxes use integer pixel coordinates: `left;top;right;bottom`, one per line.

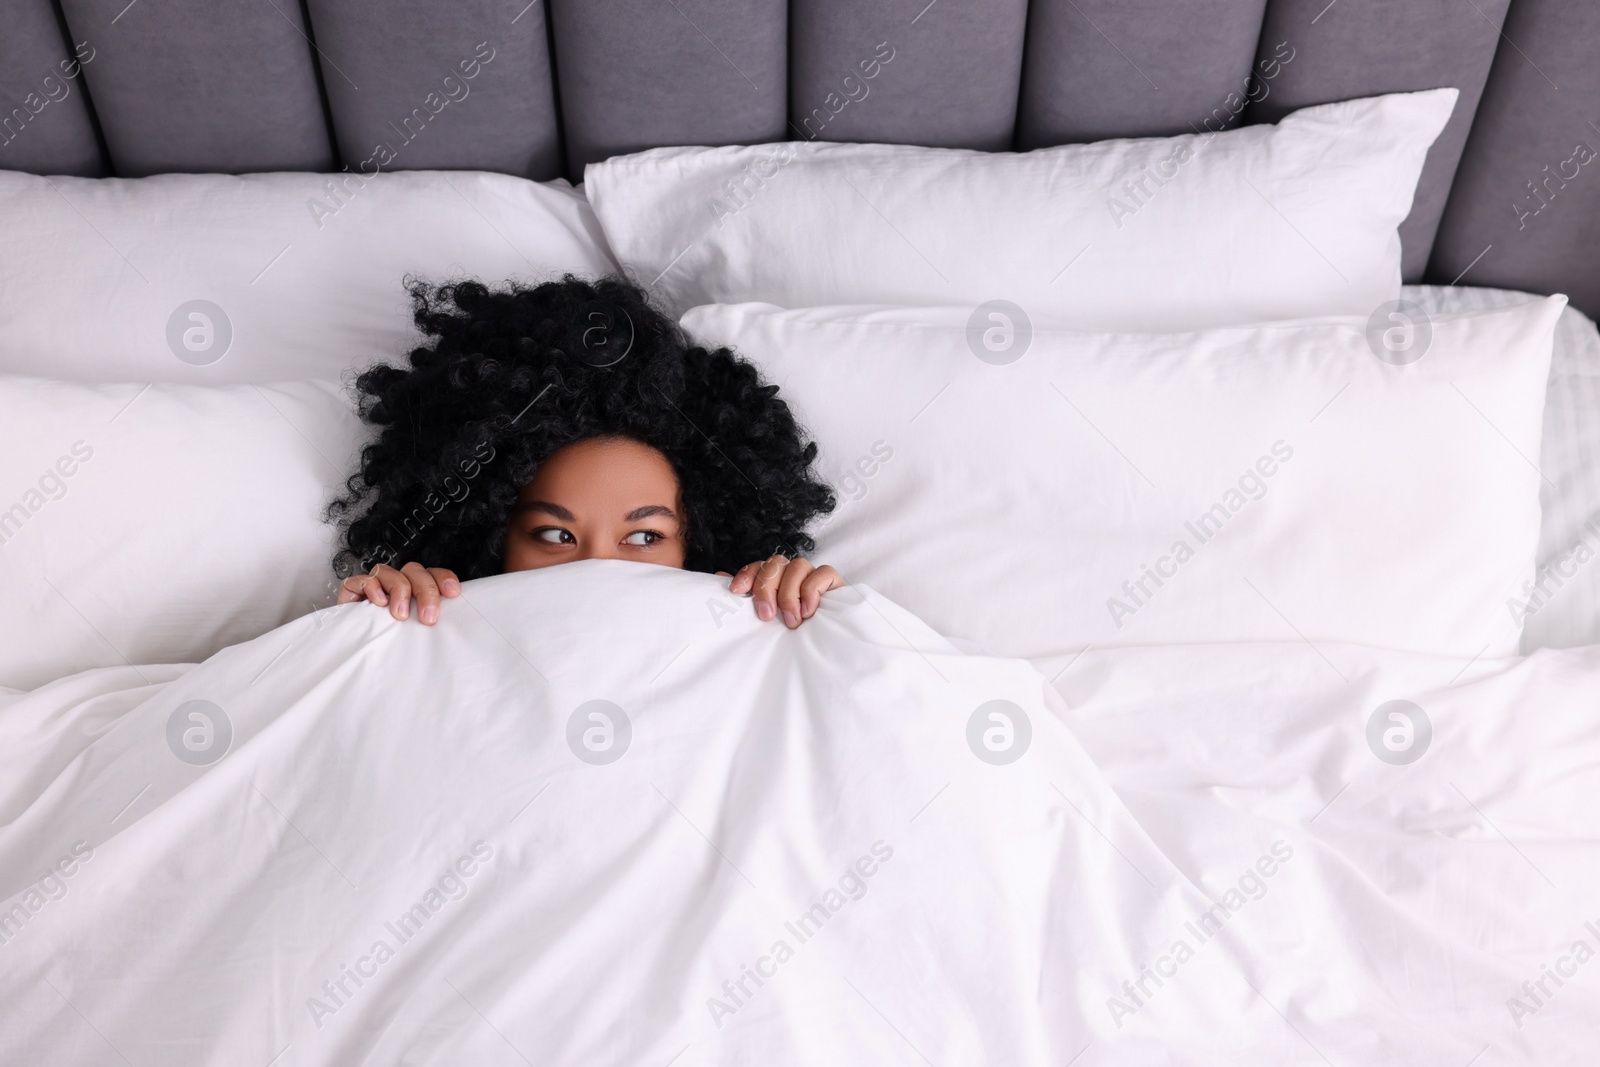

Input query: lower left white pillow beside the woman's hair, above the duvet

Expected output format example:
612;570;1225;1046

0;376;365;689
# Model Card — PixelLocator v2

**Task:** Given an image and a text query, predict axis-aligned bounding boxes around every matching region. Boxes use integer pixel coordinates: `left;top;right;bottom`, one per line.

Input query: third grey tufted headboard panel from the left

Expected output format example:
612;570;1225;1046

307;0;562;181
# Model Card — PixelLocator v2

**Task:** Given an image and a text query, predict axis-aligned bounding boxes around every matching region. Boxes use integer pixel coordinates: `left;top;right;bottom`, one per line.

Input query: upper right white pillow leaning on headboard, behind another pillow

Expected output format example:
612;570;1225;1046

584;88;1456;330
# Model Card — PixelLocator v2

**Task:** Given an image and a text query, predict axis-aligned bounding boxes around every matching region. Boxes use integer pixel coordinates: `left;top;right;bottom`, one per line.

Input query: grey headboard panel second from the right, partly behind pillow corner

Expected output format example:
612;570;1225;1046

1246;0;1509;282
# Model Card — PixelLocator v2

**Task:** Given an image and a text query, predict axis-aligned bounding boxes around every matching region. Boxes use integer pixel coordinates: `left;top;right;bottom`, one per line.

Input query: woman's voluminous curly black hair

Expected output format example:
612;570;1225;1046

328;275;834;579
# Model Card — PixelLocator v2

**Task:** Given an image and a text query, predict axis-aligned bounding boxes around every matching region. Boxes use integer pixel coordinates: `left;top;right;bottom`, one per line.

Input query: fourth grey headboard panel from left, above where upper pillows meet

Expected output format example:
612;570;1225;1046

544;0;789;181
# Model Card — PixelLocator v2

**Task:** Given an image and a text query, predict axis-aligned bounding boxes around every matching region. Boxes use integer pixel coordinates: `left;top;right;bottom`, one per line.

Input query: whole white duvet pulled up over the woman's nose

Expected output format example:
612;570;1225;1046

0;561;1600;1067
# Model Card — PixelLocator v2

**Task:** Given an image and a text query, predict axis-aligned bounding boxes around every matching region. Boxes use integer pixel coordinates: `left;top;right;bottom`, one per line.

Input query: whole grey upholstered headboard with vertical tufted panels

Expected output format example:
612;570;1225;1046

0;0;1600;315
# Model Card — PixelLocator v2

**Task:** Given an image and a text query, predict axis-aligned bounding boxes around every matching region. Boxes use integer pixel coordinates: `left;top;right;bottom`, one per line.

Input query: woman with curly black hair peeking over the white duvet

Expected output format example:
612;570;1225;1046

328;275;845;629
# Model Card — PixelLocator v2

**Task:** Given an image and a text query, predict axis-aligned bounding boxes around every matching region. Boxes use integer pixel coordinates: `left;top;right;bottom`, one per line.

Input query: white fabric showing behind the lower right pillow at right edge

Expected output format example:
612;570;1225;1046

1403;285;1600;653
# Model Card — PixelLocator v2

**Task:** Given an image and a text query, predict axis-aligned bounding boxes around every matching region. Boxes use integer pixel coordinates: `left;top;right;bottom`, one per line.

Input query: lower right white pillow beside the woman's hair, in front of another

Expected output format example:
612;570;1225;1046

683;296;1566;659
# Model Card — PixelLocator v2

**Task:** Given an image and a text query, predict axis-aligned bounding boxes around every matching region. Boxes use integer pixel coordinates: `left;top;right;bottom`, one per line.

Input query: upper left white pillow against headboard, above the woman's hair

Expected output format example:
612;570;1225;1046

0;171;616;384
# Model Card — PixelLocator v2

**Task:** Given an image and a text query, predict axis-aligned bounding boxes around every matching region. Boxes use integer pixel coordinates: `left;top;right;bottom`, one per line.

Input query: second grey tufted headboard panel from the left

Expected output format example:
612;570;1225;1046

61;0;333;178
